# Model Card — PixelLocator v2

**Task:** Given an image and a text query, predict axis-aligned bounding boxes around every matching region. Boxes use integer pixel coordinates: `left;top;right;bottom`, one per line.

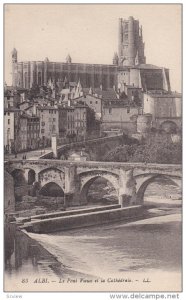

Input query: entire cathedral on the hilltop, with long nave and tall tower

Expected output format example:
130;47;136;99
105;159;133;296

12;17;170;91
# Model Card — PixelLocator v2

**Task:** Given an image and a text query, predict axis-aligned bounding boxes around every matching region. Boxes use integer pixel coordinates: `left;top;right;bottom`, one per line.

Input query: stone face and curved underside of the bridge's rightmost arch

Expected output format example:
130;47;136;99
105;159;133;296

135;174;181;204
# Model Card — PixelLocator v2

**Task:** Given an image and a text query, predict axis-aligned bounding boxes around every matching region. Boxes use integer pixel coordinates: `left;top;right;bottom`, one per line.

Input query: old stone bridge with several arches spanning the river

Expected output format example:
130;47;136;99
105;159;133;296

5;159;182;206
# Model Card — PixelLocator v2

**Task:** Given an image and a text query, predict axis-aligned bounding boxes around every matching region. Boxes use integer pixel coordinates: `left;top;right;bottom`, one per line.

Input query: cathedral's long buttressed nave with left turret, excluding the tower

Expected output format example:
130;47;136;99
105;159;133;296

12;48;117;89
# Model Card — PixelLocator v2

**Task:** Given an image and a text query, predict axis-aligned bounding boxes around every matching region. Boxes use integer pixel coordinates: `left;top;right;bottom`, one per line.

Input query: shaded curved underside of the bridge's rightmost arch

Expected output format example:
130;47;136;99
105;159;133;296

136;174;181;204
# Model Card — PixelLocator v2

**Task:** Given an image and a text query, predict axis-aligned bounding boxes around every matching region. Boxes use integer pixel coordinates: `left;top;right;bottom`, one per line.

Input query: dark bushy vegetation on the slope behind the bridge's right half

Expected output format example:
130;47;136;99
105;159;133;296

104;133;182;164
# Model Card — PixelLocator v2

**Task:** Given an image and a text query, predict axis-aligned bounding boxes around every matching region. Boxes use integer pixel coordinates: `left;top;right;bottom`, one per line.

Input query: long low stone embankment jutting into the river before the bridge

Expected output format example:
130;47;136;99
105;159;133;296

21;205;144;233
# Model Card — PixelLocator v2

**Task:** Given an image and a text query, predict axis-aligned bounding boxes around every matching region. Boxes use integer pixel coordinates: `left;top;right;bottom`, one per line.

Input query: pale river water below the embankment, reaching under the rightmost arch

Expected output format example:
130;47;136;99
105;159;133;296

4;180;182;277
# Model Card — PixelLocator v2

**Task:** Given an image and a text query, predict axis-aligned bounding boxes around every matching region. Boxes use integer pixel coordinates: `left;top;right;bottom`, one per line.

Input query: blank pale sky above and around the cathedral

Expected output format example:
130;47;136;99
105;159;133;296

4;4;182;92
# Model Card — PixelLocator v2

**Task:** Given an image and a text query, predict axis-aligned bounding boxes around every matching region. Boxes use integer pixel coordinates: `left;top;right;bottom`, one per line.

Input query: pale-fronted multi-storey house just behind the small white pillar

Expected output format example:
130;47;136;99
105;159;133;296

37;106;59;146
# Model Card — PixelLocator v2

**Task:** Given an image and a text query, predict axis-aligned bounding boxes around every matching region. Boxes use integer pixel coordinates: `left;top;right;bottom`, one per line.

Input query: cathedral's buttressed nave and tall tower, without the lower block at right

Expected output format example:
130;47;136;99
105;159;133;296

12;17;152;89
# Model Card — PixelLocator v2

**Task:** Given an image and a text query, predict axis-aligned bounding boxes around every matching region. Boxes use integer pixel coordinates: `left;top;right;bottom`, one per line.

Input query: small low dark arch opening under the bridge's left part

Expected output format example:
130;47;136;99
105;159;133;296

39;182;64;197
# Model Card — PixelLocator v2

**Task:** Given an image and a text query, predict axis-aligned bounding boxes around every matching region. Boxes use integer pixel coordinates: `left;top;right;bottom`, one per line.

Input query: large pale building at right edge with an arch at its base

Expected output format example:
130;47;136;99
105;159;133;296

143;90;182;132
